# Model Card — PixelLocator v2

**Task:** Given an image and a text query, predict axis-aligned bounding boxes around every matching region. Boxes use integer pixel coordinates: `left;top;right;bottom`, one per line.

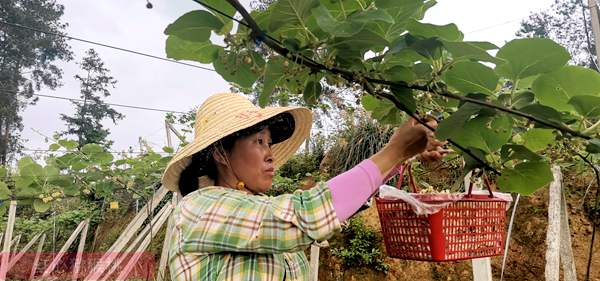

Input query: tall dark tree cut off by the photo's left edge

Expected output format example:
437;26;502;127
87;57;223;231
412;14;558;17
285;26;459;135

0;0;72;164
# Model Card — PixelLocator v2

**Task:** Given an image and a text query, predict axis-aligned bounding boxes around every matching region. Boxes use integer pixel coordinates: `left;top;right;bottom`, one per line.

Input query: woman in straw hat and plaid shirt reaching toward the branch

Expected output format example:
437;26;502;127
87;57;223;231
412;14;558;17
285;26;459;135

162;94;444;281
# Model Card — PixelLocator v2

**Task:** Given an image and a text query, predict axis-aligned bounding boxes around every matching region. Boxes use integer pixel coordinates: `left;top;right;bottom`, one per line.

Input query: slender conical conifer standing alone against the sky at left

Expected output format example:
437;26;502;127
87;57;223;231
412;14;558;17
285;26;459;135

60;49;124;148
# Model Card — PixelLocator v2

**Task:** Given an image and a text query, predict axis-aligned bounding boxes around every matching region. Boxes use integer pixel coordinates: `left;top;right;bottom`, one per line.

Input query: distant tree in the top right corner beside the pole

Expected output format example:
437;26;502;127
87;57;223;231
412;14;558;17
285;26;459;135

517;0;598;70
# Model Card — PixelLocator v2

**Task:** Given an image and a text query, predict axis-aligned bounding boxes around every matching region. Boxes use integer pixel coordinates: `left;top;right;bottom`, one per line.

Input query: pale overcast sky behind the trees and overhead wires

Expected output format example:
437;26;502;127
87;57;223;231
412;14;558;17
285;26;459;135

23;0;553;154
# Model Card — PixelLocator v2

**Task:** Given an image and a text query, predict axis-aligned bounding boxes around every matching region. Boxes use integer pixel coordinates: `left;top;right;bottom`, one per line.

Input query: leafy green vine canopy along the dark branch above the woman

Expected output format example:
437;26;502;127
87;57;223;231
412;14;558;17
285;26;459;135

165;0;600;194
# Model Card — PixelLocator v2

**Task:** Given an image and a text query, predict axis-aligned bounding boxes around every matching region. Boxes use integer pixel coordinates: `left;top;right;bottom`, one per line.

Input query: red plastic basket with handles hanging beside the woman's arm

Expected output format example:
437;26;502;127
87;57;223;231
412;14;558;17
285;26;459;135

375;164;508;262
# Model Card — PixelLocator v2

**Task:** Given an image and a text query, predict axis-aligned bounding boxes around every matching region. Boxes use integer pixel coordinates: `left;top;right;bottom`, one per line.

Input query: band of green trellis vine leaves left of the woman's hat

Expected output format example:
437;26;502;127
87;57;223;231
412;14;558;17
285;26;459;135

0;136;172;213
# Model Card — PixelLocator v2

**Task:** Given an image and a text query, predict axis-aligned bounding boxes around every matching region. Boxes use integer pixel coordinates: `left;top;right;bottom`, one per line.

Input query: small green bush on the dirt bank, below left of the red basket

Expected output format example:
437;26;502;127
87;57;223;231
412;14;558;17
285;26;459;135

331;217;390;272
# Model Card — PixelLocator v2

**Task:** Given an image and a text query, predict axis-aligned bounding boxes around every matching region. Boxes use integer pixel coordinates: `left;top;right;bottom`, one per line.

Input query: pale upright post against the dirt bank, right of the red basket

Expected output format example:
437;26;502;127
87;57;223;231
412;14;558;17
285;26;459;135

544;166;562;281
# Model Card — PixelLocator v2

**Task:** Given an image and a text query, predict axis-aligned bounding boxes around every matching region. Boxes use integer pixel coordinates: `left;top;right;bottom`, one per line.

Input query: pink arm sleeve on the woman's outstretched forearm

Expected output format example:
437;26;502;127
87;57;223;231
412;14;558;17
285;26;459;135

327;159;396;222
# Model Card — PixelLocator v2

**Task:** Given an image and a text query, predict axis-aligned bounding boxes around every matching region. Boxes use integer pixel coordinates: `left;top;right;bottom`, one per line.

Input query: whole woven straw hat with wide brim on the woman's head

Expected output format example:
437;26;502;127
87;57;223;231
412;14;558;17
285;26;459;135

161;93;312;192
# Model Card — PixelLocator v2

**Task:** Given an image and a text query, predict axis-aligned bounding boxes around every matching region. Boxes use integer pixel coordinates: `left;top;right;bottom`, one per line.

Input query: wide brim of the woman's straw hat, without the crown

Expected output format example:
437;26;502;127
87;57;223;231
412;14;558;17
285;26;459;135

161;107;312;192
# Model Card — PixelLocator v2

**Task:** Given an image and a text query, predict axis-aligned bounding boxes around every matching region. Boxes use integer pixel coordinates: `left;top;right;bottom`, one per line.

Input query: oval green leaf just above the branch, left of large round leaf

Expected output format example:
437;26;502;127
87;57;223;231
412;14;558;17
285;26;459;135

444;61;498;95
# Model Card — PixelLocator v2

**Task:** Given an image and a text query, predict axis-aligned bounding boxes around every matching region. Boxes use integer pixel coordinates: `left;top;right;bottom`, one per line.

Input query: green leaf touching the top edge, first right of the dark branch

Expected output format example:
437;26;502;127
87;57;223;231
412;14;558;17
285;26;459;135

269;0;319;31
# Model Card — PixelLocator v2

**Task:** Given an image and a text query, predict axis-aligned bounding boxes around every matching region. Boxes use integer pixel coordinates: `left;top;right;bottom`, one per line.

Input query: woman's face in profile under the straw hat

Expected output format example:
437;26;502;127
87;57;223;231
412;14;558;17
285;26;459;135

229;128;275;193
